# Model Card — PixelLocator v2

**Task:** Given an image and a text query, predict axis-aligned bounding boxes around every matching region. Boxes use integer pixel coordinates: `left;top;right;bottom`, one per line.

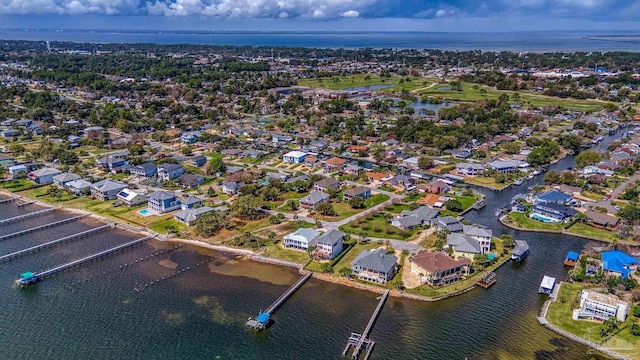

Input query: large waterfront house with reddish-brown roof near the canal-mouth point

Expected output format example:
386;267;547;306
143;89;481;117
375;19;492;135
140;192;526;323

409;250;471;286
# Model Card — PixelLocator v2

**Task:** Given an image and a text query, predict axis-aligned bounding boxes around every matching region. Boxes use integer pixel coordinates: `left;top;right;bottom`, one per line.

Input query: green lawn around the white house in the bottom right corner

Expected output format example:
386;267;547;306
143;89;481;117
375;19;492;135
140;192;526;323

547;283;640;359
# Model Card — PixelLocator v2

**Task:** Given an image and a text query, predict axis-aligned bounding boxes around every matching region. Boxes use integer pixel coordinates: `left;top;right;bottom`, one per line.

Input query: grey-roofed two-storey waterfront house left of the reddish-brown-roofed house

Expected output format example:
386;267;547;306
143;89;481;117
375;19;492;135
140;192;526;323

351;249;398;284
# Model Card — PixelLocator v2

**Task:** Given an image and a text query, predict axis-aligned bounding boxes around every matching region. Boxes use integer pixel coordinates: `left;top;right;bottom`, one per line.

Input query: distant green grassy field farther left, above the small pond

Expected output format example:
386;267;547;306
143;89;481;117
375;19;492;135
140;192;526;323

298;74;436;92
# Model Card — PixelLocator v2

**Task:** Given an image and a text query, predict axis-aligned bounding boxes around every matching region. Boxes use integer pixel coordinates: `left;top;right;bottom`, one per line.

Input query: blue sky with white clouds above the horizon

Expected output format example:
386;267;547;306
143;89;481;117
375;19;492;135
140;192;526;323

0;0;640;32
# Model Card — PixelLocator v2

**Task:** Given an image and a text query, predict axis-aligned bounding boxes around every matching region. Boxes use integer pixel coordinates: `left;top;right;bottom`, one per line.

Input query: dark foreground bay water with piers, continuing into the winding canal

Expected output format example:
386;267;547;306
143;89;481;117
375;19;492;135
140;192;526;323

0;128;614;360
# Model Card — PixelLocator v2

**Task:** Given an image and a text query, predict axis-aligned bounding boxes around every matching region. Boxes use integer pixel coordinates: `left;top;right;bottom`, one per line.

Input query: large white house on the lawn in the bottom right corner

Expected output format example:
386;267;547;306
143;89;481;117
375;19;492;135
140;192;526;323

573;290;629;322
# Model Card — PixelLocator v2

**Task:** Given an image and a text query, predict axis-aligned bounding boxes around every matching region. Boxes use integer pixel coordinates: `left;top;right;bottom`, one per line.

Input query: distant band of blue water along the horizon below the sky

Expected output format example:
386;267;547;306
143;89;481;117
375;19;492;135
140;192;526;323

0;30;640;51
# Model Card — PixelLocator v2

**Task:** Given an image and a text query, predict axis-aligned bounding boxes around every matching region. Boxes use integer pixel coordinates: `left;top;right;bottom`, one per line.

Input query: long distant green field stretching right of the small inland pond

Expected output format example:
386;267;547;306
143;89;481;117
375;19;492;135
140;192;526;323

418;83;606;111
